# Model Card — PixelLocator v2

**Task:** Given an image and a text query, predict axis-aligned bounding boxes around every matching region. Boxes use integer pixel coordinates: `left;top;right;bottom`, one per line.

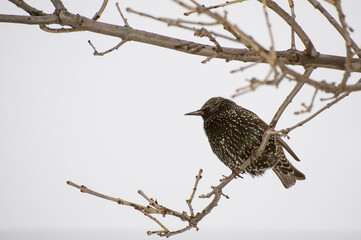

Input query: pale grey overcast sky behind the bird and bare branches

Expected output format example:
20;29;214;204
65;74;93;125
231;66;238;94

0;0;361;239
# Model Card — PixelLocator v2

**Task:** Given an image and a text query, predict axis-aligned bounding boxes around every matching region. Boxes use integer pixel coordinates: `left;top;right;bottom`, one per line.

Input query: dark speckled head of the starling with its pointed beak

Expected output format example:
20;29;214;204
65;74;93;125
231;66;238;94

185;97;237;119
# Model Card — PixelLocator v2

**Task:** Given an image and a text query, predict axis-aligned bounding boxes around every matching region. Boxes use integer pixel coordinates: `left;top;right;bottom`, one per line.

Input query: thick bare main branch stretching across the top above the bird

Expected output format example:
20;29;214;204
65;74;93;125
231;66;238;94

0;6;361;72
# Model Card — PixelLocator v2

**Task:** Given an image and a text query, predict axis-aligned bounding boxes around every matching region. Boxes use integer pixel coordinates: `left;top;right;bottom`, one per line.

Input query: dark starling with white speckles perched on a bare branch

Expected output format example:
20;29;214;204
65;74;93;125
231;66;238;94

185;97;306;189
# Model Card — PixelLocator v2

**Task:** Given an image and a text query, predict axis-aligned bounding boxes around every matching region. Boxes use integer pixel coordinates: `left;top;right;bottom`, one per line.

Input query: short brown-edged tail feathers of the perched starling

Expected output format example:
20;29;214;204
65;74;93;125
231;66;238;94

273;156;306;188
